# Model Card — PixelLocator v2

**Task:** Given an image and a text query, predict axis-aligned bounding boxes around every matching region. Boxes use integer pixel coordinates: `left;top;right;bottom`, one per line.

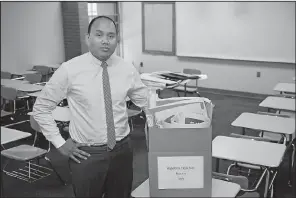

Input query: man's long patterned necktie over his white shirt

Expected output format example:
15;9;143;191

101;62;116;150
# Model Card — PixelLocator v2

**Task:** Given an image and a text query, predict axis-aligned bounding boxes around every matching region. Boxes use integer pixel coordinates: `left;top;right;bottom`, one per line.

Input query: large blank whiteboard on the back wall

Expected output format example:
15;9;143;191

175;2;295;63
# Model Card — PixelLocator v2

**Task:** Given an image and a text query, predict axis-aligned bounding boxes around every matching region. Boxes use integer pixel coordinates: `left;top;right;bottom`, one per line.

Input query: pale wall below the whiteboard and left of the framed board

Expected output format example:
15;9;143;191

122;2;295;94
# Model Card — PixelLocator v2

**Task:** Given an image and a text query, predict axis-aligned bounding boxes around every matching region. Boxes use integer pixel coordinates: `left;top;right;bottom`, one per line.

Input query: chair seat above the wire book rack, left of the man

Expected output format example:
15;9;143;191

1;144;47;161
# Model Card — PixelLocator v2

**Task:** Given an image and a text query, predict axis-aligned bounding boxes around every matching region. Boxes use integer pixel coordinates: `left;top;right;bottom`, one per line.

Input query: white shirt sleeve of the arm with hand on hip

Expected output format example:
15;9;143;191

33;64;69;148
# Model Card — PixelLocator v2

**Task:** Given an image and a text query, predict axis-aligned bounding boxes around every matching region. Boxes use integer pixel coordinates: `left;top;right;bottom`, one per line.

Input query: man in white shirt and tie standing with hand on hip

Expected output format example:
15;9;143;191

33;16;148;198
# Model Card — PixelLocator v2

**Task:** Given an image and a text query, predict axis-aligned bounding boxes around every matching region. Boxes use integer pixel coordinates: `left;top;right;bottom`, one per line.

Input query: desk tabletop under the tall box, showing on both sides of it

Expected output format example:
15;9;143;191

132;179;241;198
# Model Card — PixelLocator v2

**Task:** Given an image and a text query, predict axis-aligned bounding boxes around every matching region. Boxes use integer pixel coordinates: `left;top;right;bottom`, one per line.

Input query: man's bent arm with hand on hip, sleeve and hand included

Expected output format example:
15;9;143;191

33;64;90;163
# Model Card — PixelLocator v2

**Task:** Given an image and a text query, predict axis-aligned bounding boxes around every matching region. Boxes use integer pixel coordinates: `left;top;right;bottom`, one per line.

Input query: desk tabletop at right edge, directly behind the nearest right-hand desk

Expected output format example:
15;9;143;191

231;113;295;135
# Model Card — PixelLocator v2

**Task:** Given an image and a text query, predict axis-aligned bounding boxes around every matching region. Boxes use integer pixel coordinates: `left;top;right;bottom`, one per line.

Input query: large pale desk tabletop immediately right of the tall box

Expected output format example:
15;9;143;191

212;136;286;168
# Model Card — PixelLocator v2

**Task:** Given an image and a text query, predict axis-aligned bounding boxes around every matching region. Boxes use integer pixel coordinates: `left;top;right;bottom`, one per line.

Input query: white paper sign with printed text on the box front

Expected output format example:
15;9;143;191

157;156;204;189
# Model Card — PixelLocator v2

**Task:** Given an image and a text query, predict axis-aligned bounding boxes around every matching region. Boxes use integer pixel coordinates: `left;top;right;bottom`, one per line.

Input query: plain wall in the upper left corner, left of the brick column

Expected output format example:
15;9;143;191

1;2;65;72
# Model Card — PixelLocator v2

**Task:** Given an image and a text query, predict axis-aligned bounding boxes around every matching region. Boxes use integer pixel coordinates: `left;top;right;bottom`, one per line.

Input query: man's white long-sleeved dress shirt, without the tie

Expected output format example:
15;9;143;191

33;52;148;148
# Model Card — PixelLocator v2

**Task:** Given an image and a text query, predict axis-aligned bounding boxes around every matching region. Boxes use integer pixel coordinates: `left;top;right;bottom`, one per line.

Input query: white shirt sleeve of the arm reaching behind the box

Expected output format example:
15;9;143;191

128;69;148;112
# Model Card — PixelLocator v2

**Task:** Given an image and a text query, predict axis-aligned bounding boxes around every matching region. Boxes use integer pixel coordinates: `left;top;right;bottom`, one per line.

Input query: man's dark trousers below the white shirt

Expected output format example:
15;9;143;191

69;137;133;198
